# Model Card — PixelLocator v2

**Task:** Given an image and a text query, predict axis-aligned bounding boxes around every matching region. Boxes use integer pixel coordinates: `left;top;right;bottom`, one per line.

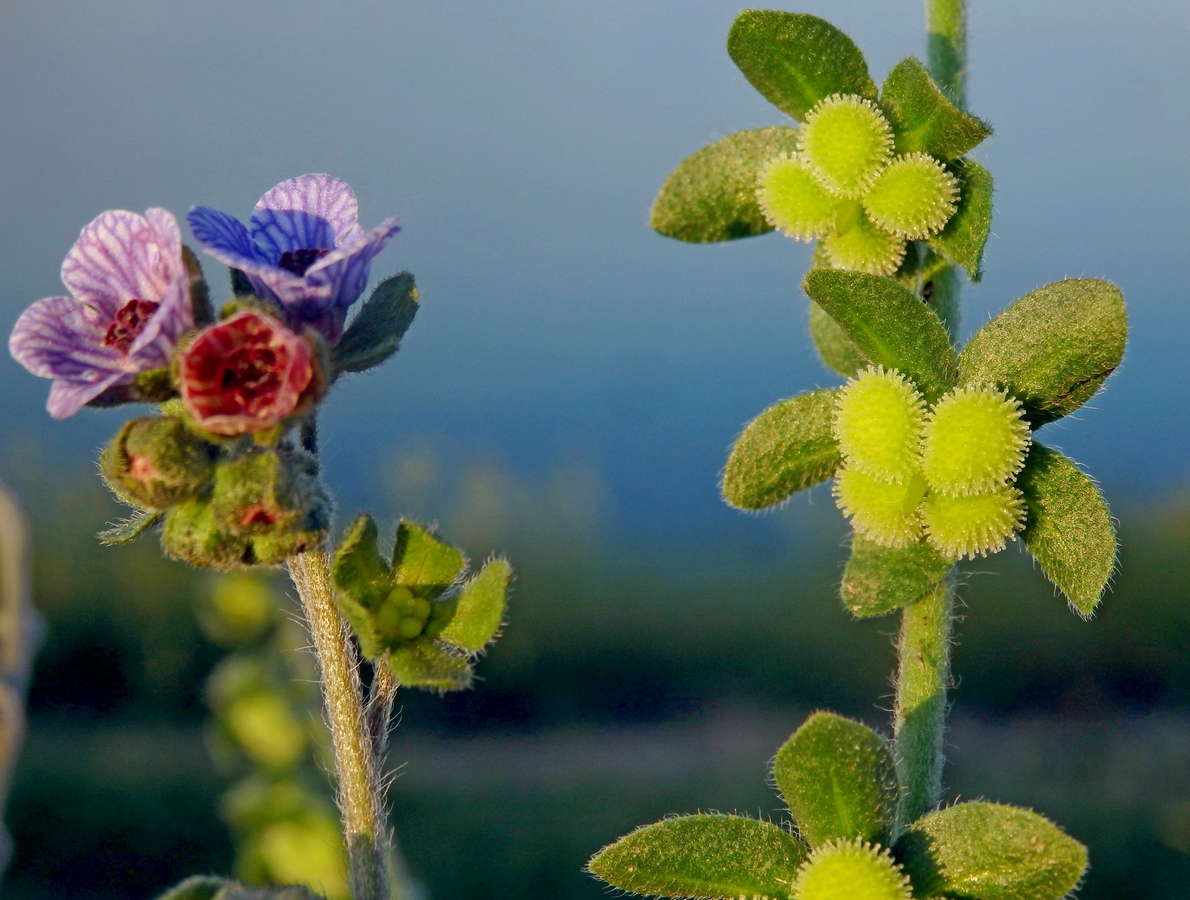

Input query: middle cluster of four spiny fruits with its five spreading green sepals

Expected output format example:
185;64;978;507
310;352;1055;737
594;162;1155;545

724;269;1127;617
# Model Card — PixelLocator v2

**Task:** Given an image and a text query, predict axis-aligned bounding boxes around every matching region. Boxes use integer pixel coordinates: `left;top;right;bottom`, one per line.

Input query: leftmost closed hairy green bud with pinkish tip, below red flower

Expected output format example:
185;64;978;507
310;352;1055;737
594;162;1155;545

100;415;217;510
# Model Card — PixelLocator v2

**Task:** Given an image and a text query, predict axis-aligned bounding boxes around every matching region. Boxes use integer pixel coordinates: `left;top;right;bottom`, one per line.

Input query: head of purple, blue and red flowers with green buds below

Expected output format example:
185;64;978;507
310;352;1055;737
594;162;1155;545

8;175;407;569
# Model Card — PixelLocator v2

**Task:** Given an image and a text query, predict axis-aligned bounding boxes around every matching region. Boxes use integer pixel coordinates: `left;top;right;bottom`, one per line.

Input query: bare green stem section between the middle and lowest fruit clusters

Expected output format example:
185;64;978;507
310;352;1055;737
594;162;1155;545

893;569;954;825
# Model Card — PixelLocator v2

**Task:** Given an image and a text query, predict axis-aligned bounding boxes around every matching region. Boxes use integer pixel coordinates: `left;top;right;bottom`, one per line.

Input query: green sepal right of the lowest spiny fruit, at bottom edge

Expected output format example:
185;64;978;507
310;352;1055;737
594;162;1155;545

896;802;1086;900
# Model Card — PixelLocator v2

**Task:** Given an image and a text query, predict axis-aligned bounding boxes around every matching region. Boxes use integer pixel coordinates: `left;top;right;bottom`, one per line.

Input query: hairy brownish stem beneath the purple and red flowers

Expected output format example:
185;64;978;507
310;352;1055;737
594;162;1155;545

289;550;389;900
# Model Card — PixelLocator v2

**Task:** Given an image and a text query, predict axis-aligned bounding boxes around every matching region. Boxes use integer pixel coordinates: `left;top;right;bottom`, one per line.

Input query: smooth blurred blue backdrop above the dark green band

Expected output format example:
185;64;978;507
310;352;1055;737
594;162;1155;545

0;0;1190;539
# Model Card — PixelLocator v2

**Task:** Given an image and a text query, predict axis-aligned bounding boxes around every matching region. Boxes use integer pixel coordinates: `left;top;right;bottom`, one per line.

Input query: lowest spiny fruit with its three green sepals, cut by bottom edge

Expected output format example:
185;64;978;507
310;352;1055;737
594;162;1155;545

589;713;1086;900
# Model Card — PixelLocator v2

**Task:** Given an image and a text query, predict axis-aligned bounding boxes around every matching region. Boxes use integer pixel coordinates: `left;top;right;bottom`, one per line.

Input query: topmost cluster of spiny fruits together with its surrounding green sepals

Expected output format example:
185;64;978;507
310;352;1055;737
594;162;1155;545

652;10;991;279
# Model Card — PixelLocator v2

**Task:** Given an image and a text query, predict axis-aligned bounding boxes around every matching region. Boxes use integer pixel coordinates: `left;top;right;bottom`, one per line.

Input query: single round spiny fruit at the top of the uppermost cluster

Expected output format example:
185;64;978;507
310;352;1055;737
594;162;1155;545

798;94;893;198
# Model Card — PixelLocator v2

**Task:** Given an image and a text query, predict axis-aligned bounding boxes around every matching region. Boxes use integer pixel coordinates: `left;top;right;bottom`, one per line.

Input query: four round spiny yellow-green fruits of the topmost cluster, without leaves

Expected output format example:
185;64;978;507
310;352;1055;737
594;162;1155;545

757;94;959;275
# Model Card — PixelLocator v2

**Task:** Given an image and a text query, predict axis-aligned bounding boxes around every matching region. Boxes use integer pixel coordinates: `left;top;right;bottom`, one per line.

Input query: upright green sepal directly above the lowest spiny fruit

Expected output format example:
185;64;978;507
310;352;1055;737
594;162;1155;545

772;712;897;849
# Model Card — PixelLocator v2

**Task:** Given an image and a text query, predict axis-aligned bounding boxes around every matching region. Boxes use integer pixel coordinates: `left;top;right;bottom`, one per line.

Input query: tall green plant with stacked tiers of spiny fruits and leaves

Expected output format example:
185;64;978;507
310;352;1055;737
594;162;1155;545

590;0;1127;900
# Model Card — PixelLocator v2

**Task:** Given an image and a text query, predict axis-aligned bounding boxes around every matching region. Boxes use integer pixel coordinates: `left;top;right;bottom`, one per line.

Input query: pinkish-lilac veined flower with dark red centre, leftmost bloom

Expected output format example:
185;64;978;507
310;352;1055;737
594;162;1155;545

8;208;194;419
